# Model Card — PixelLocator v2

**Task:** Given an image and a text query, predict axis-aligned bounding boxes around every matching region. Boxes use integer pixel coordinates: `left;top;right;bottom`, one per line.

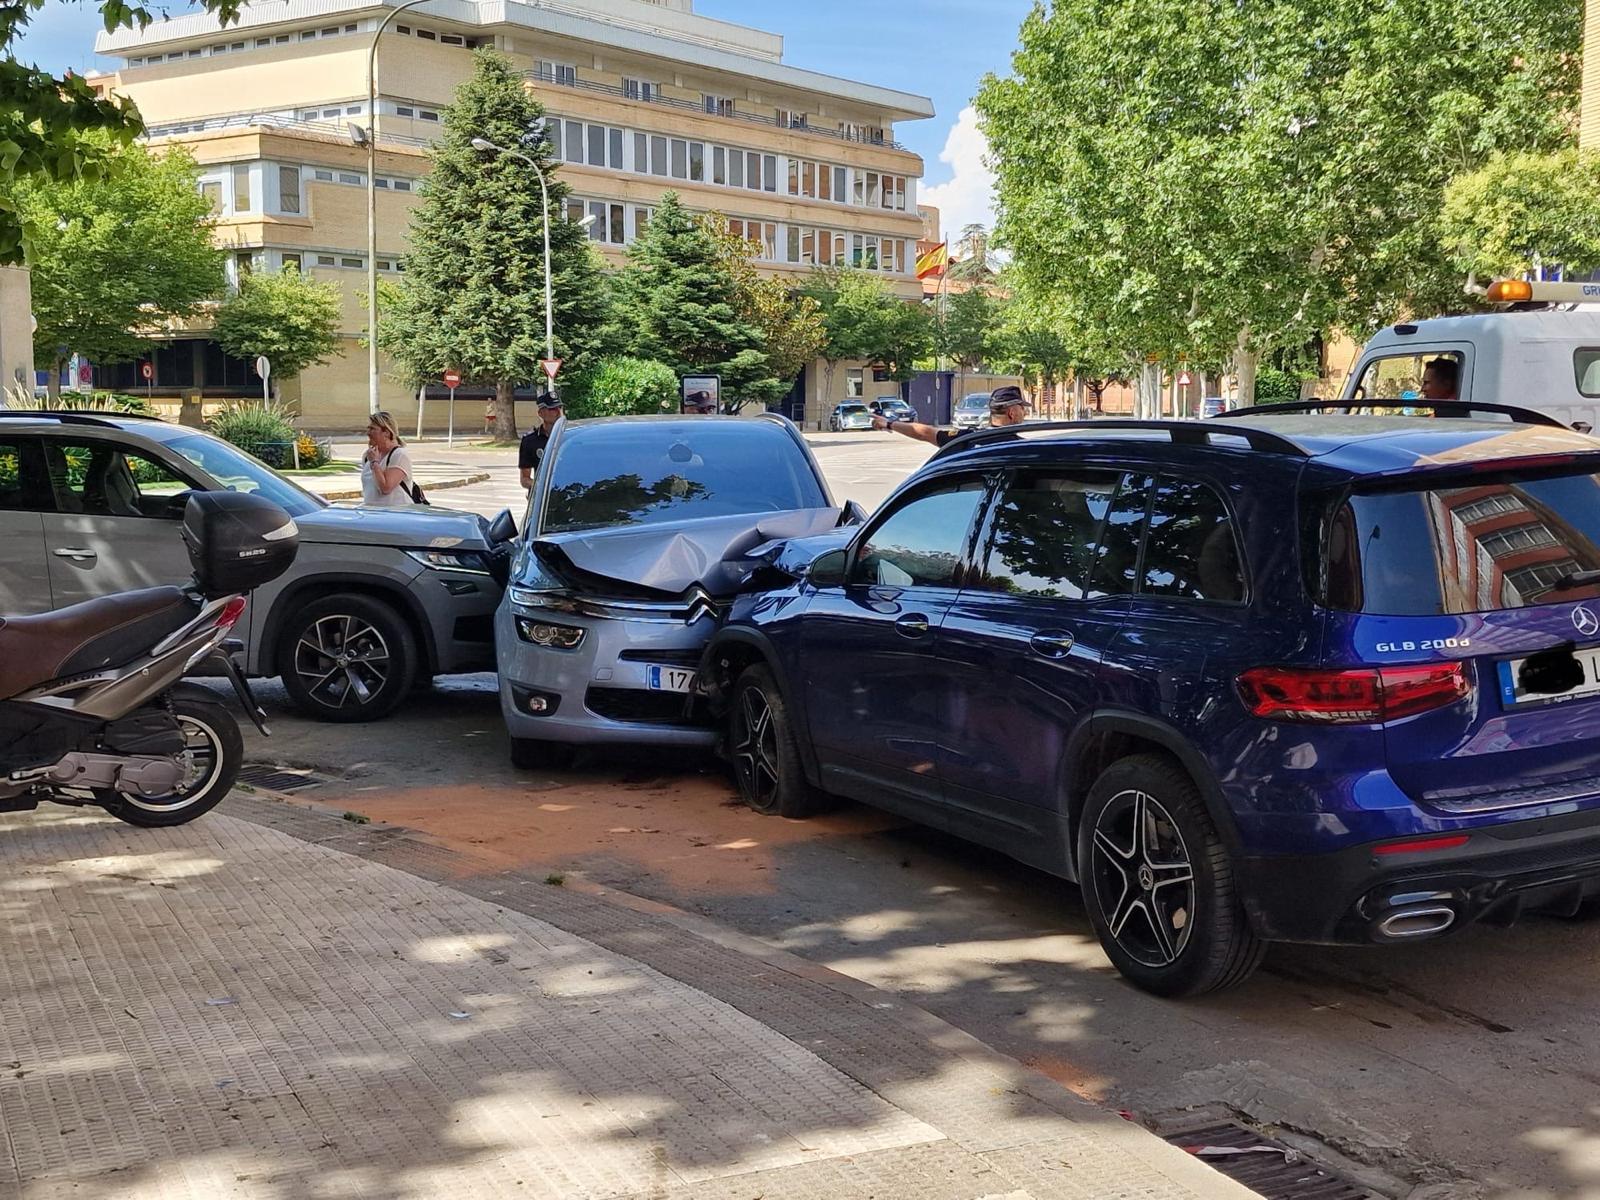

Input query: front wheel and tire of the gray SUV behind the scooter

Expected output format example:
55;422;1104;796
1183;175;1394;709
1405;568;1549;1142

278;592;418;723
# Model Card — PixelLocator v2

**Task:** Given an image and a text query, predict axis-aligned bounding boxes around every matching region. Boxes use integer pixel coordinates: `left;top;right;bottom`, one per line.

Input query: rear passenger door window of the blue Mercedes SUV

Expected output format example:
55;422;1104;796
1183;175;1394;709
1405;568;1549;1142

981;470;1118;600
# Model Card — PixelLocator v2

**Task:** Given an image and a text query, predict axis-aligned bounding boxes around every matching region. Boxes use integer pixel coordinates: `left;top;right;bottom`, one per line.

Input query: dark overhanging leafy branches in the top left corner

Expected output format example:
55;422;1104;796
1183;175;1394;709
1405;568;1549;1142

0;0;240;264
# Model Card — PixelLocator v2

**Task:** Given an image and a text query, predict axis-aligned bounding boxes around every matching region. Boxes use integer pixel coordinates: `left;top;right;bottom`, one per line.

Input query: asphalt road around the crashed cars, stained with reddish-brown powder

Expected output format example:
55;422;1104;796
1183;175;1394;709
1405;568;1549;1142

250;434;1600;1200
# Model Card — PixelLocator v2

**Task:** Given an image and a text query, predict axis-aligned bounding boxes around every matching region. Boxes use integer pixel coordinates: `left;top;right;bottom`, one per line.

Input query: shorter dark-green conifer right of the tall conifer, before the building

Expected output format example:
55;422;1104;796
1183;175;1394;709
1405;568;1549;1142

614;192;774;410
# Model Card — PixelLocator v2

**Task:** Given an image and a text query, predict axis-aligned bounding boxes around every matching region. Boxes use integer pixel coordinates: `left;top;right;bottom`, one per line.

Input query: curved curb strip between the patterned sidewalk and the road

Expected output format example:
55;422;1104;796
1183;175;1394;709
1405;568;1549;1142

222;787;1256;1200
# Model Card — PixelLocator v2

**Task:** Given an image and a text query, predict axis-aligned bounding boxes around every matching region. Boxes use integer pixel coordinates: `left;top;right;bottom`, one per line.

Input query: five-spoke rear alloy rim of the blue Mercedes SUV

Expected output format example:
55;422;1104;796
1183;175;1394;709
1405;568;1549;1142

1090;789;1195;968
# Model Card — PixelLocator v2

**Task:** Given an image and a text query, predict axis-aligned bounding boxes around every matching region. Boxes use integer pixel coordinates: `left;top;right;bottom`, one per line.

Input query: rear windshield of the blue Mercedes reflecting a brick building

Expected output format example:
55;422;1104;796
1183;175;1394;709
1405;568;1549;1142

1326;475;1600;616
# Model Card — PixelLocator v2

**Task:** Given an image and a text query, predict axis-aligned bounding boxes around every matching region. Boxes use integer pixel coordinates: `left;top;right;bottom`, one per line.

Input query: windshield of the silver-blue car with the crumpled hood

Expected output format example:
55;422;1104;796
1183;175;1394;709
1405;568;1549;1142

539;418;827;533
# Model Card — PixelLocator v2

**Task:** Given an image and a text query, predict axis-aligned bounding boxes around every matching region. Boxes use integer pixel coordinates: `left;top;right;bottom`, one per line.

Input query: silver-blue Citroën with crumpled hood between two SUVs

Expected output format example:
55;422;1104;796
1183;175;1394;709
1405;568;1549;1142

494;414;861;766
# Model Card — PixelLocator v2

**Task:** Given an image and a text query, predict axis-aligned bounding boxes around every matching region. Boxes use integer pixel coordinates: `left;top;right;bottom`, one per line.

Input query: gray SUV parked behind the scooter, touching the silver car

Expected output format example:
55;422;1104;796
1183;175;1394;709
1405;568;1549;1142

0;410;512;722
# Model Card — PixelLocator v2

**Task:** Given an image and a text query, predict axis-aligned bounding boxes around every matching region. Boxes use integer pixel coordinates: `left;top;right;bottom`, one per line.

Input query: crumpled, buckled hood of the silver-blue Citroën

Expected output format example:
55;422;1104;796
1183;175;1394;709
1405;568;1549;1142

533;509;842;595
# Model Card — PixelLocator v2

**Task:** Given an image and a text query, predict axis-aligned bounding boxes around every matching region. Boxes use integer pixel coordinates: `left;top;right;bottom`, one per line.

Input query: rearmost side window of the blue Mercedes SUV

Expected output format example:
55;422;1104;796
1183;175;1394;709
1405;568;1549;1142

1139;478;1245;603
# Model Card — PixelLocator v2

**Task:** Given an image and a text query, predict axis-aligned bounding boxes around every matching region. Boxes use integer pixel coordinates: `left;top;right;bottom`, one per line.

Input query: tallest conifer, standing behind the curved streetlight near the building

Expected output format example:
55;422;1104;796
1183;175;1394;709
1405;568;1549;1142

378;48;606;440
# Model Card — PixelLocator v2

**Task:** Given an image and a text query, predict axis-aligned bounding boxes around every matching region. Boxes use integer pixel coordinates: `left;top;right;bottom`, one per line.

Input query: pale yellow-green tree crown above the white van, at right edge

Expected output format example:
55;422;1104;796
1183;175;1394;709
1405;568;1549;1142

1440;147;1600;278
